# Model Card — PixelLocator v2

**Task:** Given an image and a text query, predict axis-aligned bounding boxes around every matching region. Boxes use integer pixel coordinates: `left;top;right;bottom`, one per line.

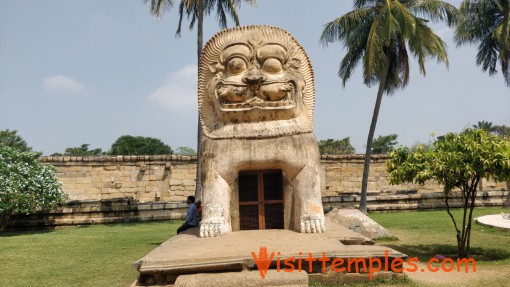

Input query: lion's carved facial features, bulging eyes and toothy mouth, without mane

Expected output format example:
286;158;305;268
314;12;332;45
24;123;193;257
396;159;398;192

211;40;304;119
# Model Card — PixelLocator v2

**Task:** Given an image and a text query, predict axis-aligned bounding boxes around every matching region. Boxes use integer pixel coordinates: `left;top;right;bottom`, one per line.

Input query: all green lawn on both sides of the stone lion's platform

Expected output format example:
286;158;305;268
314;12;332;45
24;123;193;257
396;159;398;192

0;208;510;287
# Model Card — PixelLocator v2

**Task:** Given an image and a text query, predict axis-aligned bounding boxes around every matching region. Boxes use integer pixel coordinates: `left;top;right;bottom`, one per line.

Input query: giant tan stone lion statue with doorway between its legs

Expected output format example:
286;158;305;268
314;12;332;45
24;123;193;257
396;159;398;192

198;26;325;237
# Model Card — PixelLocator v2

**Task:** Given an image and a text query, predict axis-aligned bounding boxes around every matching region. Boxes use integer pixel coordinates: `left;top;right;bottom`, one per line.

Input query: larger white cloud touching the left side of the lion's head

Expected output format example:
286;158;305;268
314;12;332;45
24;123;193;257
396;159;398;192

147;65;198;111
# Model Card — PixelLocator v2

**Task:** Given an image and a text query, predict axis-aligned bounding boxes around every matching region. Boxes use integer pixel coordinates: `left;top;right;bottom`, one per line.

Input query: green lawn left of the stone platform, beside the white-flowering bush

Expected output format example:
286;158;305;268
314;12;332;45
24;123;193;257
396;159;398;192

0;221;181;287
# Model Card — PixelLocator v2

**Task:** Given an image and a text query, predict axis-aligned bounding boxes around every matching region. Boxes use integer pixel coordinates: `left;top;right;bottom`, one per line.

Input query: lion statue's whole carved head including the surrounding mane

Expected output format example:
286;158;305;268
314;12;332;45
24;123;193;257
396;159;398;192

199;26;314;138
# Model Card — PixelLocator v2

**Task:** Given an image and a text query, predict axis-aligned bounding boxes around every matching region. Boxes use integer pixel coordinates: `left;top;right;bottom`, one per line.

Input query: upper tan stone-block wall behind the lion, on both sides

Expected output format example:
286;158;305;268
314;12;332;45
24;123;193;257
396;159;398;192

41;155;508;203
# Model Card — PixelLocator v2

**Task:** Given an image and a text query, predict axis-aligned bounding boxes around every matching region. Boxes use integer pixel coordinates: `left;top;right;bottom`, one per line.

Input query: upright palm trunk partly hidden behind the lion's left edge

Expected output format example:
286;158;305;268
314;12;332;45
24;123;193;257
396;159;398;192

195;0;205;200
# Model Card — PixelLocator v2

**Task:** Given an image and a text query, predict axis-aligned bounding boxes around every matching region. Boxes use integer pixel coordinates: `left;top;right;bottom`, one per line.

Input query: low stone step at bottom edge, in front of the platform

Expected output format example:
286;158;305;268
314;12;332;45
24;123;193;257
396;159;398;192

175;270;308;287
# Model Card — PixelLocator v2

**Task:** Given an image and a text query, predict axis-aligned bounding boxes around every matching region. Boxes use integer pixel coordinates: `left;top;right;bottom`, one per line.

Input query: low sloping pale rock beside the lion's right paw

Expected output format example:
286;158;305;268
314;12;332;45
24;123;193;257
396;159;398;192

326;208;392;239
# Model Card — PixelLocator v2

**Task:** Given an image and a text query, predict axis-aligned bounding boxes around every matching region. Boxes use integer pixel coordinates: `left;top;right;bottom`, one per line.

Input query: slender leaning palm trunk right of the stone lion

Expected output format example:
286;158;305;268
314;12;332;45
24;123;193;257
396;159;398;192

359;59;390;214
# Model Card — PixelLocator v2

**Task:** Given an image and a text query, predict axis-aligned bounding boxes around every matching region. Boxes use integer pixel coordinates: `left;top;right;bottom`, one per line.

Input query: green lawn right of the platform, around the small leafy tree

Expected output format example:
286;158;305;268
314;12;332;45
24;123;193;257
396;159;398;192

369;207;510;266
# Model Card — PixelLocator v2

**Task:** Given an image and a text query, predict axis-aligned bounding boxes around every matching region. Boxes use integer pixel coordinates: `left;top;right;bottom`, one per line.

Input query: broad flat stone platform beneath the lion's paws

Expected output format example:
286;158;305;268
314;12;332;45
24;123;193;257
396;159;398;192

133;228;406;287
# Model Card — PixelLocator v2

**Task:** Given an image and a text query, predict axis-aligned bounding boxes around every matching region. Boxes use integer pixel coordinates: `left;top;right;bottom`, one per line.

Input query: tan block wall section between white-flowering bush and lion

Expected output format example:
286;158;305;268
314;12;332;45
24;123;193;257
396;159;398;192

41;155;196;203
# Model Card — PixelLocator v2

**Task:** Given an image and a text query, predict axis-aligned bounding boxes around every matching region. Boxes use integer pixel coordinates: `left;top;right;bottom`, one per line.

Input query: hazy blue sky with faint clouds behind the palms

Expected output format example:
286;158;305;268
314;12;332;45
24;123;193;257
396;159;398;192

0;0;510;155
